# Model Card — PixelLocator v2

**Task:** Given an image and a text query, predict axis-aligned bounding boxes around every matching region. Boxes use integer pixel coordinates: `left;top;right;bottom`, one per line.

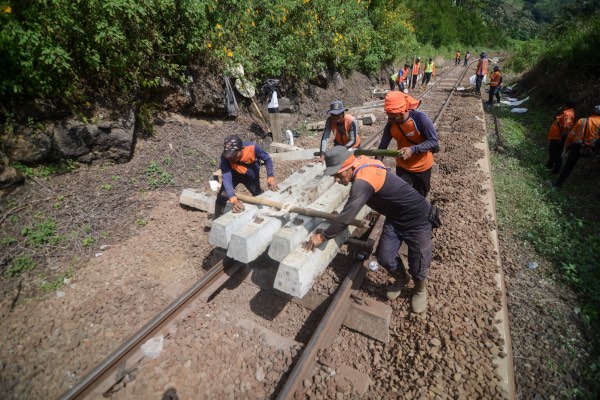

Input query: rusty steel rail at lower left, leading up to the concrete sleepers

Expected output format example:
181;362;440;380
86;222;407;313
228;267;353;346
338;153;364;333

59;259;241;400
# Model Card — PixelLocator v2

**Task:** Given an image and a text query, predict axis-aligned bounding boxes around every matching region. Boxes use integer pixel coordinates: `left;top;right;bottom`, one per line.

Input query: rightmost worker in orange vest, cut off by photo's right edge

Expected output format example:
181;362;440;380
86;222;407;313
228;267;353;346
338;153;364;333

552;105;600;187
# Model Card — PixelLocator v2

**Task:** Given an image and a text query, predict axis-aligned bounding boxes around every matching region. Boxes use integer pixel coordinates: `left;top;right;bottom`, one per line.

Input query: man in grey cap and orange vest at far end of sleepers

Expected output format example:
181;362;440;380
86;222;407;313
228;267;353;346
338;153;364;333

321;100;360;161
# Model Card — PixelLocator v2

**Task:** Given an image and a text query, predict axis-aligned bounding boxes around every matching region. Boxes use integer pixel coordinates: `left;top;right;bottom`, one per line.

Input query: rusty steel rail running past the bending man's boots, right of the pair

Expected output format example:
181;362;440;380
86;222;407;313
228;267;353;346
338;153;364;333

277;216;385;400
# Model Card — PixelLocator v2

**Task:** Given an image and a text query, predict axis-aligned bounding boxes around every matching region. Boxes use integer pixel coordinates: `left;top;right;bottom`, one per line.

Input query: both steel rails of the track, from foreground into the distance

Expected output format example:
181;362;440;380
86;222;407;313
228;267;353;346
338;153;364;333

59;62;486;400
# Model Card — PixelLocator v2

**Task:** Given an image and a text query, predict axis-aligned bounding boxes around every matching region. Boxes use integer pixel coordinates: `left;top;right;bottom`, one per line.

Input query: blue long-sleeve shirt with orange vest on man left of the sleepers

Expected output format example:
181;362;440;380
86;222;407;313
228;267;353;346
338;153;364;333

221;142;275;201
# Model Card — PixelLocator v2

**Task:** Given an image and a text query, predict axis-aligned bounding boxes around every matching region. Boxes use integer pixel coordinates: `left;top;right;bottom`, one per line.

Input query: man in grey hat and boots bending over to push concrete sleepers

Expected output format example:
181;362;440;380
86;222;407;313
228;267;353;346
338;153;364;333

305;146;436;313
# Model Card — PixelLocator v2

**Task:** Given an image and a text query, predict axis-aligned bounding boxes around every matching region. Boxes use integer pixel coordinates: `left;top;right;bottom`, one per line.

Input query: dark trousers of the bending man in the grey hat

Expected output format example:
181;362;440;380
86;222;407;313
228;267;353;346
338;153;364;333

375;222;432;281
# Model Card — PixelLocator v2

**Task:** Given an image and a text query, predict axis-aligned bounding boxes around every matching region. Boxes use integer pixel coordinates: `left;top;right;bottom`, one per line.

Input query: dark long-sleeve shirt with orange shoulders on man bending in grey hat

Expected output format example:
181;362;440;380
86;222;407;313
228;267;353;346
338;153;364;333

323;156;431;239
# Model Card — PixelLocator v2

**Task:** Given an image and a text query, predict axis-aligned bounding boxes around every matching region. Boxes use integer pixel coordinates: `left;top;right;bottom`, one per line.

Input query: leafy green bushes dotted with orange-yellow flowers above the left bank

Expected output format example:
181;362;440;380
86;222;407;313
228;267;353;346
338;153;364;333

0;0;414;109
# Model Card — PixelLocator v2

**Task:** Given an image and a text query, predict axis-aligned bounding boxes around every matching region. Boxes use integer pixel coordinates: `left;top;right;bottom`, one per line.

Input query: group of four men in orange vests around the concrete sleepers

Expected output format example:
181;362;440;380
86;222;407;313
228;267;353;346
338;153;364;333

215;91;439;313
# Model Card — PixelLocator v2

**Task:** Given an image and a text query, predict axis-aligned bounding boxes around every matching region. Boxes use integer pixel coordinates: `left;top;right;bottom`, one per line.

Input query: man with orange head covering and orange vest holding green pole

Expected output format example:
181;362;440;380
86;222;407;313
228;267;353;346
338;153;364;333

378;92;439;197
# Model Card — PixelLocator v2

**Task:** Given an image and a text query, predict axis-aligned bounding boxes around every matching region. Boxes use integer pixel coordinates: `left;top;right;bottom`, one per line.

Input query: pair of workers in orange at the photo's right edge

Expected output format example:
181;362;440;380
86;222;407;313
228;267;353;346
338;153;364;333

546;99;600;187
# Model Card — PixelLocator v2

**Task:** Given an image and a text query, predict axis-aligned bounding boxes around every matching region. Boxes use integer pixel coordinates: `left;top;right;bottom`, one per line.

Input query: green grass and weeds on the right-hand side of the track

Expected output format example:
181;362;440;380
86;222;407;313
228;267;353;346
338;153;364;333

492;109;600;398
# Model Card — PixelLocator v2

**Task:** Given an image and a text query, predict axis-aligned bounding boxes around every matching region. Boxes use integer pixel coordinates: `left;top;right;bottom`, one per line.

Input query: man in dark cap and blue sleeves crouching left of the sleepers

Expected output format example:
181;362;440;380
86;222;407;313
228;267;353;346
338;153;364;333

214;135;279;219
